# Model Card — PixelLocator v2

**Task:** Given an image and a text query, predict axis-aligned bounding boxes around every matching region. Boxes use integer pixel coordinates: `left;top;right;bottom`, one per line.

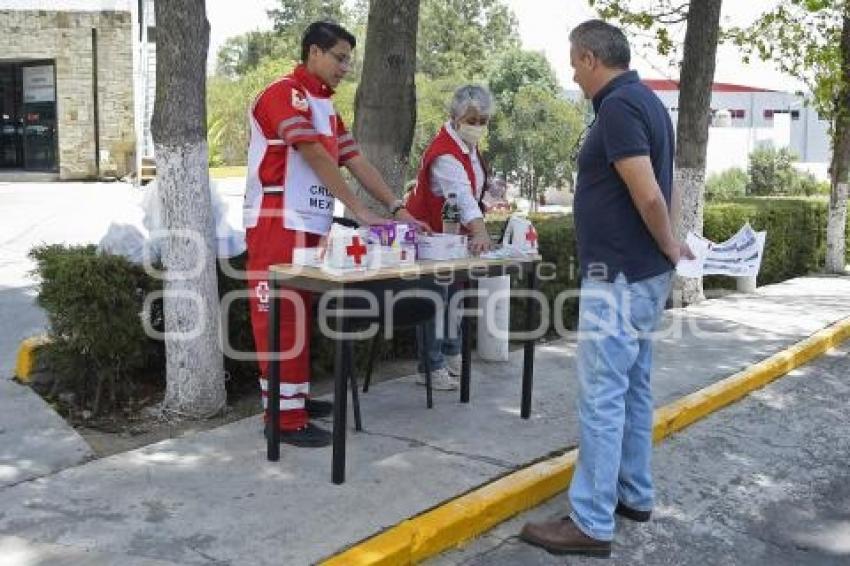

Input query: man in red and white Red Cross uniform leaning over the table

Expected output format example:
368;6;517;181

243;22;422;447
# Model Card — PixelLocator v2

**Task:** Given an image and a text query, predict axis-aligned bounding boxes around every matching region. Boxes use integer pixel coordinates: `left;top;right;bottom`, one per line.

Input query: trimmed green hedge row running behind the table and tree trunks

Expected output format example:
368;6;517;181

32;198;850;409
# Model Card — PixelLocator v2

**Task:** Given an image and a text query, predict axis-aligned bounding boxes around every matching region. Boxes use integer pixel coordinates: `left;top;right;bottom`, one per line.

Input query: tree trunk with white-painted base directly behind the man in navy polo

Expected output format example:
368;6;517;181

673;0;722;304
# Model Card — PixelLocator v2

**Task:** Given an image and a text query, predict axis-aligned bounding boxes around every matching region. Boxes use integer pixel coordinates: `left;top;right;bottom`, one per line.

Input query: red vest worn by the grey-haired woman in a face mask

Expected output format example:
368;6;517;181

405;126;487;232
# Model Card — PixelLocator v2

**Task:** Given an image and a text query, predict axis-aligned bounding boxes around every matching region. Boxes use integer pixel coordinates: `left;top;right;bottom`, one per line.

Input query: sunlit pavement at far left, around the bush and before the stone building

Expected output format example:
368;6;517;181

0;179;244;488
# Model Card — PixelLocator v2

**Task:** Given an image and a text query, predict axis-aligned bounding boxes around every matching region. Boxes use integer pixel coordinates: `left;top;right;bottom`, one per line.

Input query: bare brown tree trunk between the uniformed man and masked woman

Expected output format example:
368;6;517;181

354;0;419;211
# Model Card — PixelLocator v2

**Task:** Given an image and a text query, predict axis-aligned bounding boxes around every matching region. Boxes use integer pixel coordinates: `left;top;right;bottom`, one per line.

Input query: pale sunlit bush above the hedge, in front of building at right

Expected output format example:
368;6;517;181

747;147;829;196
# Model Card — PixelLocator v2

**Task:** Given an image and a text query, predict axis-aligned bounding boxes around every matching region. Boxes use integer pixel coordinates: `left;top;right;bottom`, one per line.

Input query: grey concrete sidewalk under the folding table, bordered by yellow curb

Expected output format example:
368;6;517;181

0;277;850;565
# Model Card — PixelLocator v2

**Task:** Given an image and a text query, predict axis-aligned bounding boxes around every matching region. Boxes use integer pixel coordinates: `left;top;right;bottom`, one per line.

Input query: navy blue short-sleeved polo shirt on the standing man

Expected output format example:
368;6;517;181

573;71;674;282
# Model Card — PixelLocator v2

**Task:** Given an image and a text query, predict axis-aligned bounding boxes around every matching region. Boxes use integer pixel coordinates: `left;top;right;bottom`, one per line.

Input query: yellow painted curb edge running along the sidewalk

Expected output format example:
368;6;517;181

322;317;850;566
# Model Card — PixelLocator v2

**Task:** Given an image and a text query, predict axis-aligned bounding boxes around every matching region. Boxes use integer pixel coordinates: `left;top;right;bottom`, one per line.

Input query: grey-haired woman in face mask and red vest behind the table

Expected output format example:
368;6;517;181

406;85;494;391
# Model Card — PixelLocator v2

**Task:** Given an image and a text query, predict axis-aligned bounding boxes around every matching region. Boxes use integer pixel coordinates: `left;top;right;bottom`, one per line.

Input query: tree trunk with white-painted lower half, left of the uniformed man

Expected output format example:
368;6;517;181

151;0;226;418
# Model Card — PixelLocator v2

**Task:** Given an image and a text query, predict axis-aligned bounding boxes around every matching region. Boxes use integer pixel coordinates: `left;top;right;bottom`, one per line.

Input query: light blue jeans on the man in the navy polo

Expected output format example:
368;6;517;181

569;272;672;541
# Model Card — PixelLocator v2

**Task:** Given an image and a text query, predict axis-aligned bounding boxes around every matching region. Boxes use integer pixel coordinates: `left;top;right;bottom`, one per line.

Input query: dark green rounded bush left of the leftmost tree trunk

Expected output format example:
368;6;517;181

30;245;164;415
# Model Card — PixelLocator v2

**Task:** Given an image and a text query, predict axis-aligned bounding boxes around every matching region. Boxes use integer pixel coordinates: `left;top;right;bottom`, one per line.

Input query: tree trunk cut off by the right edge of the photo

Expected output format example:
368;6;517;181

826;1;850;273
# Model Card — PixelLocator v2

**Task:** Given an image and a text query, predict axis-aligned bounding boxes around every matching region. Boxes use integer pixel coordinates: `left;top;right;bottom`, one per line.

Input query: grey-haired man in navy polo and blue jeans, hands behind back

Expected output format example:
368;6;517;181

520;20;692;556
